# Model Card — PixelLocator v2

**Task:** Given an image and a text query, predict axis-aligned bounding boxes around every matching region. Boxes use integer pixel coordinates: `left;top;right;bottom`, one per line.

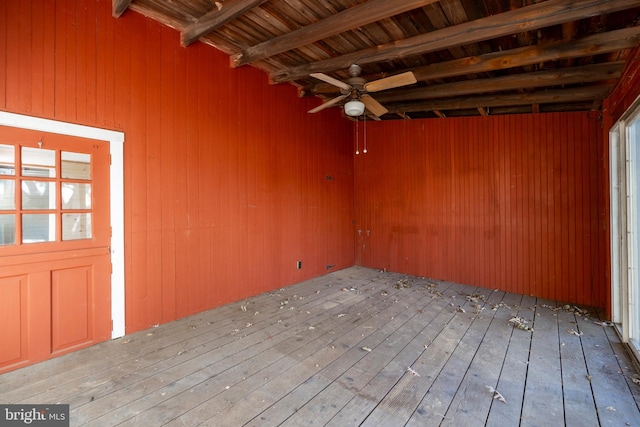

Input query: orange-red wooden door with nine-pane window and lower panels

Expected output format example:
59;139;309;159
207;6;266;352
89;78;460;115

0;126;111;373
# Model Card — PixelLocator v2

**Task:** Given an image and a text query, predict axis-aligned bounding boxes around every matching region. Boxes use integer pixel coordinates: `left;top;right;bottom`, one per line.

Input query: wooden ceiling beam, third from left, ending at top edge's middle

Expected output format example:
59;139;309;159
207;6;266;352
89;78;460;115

231;0;438;67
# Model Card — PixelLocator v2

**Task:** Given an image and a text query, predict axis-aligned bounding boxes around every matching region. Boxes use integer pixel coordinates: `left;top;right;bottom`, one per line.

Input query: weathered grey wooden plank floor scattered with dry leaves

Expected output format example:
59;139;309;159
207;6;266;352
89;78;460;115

0;267;640;427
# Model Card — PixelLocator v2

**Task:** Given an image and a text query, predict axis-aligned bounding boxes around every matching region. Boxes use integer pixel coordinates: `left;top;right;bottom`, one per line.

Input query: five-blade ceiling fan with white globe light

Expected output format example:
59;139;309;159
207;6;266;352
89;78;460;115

309;64;417;117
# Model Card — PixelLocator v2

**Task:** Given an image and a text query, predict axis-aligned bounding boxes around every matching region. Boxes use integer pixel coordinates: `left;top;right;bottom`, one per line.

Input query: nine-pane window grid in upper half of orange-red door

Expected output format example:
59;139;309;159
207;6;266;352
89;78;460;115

0;143;93;245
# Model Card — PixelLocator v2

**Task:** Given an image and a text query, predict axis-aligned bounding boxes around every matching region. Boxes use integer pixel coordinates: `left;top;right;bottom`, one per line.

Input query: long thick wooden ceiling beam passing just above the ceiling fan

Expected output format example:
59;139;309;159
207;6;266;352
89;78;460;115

270;0;638;83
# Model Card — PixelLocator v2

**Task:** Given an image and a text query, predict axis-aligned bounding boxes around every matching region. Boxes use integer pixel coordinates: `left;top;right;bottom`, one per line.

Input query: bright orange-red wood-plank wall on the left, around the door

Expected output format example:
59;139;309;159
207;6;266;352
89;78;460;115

0;0;354;332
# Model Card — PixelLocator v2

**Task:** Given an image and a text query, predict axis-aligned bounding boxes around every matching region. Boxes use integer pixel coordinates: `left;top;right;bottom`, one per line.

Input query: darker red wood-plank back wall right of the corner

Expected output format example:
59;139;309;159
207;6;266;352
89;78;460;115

355;113;608;306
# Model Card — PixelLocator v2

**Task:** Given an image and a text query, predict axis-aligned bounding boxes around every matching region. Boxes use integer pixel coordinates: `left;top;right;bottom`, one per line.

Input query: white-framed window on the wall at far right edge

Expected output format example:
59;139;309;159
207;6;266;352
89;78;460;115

609;99;640;359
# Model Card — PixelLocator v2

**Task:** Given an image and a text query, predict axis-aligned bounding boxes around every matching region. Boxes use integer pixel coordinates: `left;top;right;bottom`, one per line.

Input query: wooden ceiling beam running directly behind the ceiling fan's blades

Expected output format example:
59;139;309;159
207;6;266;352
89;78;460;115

301;26;640;96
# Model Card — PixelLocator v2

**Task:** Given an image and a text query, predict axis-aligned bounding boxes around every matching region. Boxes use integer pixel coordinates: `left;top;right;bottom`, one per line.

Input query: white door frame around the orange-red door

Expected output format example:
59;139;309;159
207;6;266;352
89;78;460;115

0;111;125;339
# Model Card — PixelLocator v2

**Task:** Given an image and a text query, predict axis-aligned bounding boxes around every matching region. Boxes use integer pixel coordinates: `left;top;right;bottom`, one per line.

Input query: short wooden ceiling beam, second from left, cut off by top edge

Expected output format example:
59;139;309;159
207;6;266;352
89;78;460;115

180;0;267;46
